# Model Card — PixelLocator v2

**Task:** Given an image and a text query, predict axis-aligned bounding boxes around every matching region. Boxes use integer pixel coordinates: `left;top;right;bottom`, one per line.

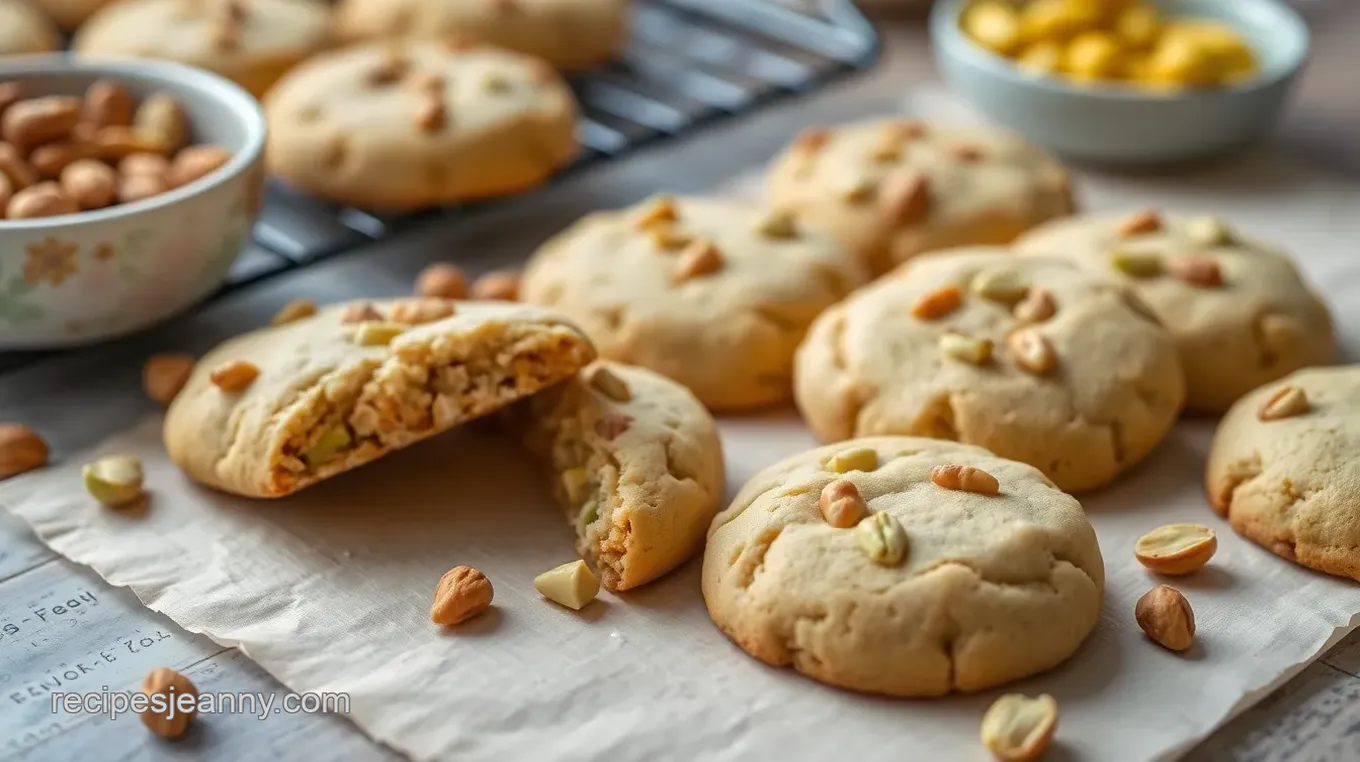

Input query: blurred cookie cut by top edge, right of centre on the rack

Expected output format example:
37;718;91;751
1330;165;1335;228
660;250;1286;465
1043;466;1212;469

335;0;628;69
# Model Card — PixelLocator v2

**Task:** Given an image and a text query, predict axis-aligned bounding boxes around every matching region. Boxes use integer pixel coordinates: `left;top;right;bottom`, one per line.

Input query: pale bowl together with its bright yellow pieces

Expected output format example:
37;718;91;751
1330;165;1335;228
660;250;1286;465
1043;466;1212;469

930;0;1308;165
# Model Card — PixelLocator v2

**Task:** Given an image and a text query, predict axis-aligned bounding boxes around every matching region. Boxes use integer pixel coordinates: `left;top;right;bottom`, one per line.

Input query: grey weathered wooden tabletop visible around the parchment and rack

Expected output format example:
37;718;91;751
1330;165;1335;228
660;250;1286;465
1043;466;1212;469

0;0;1360;762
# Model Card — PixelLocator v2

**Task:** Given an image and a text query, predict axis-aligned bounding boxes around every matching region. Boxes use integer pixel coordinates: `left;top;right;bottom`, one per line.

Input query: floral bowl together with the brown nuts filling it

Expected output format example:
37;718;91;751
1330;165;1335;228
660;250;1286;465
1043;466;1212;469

0;56;265;350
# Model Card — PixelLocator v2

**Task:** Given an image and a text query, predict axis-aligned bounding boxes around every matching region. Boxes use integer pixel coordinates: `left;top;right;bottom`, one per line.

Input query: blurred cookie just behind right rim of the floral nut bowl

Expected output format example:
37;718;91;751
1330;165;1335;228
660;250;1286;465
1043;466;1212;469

73;0;330;97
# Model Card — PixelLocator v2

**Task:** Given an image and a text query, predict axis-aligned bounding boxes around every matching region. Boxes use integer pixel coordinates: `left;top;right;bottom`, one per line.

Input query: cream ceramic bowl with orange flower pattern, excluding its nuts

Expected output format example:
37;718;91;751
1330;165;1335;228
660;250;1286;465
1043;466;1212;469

0;56;265;350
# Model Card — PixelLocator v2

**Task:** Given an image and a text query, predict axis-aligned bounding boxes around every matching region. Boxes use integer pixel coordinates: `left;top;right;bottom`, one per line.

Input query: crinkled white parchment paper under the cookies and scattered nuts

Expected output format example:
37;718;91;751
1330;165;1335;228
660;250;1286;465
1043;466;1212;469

0;101;1360;762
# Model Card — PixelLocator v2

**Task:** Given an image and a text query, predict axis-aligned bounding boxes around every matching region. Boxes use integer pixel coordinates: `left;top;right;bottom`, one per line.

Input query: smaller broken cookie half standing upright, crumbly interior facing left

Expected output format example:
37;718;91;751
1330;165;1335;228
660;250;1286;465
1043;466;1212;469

513;361;724;591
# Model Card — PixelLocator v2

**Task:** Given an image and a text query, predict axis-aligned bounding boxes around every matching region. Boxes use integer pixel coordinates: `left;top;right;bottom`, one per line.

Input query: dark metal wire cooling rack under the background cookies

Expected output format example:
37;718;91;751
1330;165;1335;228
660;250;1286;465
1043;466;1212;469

0;0;879;373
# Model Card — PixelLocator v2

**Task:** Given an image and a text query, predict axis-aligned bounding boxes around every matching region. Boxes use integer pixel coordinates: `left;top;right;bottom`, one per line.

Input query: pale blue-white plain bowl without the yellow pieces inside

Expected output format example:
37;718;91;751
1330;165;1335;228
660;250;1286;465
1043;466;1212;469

930;0;1308;165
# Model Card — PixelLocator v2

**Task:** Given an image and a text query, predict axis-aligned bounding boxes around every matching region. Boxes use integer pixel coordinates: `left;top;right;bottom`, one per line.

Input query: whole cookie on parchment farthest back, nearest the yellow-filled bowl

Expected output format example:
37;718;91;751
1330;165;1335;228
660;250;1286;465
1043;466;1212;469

767;118;1073;274
